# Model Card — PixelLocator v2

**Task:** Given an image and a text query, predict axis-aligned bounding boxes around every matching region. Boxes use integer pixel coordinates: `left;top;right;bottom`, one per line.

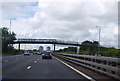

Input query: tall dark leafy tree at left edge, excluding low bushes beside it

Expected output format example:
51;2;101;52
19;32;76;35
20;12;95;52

0;27;16;52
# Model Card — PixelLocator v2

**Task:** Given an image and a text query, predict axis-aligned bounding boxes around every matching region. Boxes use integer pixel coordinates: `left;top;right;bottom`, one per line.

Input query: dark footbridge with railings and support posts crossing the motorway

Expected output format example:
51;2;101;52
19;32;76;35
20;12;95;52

11;39;81;51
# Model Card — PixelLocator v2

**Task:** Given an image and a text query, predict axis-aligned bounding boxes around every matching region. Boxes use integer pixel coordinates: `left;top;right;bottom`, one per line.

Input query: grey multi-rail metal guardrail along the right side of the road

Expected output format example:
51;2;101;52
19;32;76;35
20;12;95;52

53;54;120;79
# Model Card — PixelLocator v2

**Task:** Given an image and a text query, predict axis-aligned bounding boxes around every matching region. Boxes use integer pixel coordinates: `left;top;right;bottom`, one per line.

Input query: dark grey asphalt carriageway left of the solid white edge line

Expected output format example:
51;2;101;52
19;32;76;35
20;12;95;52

2;54;89;81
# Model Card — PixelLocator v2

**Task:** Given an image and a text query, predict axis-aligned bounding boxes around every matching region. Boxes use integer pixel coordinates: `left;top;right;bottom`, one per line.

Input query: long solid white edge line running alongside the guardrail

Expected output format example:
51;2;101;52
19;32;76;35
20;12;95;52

54;57;96;81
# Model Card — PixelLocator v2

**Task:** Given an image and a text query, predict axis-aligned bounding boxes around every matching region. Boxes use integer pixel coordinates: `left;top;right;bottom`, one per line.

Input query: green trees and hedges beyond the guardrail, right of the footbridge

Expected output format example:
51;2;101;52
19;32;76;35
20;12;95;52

57;40;120;57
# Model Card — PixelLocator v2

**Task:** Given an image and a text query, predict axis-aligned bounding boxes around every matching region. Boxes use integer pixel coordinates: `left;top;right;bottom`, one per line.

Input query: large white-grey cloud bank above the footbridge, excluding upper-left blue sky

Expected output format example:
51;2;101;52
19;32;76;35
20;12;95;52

1;2;118;46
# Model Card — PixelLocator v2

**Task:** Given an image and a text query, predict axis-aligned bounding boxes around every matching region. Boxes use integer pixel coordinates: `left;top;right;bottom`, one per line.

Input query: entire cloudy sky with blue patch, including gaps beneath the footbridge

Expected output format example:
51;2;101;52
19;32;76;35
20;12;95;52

0;0;118;49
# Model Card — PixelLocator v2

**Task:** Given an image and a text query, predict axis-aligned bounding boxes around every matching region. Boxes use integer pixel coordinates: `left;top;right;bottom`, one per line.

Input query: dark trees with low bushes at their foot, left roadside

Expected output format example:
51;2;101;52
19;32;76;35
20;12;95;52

0;27;22;55
